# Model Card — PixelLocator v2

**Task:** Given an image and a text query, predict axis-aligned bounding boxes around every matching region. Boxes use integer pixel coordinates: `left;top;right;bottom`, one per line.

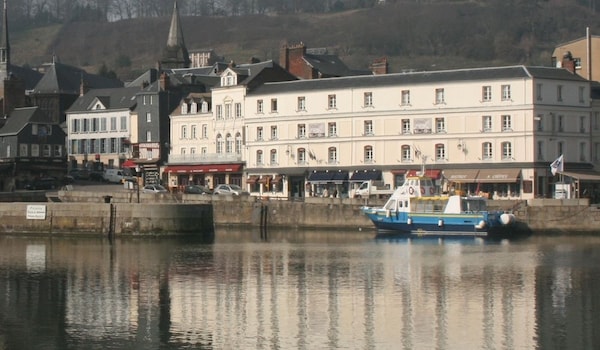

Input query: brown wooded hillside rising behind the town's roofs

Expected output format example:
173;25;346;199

11;1;600;79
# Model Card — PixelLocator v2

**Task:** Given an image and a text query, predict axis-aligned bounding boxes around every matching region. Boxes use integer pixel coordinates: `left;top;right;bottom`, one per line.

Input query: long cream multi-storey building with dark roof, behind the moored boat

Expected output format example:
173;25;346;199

241;66;600;199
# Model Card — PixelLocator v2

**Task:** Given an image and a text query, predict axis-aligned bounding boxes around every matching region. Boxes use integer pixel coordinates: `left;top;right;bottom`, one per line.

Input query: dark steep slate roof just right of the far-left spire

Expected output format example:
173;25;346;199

33;62;123;95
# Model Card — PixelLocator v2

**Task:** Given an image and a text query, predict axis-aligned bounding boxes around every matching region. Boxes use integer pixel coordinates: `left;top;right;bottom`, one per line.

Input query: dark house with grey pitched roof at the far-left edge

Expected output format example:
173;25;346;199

0;107;67;191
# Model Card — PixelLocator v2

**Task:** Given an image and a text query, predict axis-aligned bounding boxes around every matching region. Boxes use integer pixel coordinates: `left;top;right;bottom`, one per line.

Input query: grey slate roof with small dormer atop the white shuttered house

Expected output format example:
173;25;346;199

66;87;140;113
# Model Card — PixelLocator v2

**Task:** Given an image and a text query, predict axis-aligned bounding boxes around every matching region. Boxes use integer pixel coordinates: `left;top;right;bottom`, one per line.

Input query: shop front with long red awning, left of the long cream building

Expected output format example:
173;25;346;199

163;164;242;192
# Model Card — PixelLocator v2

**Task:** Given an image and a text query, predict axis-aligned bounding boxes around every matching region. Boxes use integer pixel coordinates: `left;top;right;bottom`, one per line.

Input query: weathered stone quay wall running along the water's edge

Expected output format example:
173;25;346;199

0;191;600;236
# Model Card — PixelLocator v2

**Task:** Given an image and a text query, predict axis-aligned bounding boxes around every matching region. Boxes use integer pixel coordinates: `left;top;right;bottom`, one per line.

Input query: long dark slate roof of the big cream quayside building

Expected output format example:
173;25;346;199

247;66;587;94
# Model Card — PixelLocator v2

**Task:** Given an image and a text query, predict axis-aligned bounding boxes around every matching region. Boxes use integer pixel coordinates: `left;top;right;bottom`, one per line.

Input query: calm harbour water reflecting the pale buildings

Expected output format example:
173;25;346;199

0;231;600;350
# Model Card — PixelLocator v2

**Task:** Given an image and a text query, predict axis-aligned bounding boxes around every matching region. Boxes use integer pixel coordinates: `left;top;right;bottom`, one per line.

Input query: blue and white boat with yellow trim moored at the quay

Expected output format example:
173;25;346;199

362;175;529;238
